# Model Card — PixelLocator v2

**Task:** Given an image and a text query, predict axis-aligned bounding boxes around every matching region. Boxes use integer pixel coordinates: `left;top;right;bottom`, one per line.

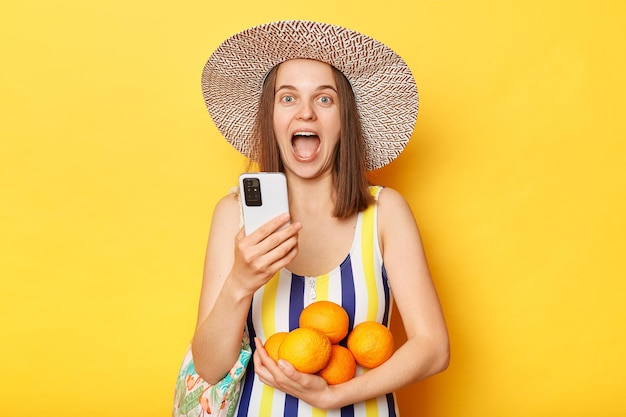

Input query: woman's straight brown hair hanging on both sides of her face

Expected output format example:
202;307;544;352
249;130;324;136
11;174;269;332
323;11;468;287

252;62;373;218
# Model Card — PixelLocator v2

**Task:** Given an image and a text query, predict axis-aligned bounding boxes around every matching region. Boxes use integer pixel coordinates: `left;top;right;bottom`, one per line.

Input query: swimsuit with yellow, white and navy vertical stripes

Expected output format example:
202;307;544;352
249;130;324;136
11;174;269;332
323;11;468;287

232;187;399;417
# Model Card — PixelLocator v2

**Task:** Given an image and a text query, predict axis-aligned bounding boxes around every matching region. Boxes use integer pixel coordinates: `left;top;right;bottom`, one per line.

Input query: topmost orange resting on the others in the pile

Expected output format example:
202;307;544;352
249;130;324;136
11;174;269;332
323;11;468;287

300;301;348;344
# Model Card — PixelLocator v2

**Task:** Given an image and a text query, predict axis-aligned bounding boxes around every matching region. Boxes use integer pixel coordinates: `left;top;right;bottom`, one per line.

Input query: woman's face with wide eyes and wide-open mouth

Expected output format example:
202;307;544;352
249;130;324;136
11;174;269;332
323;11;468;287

274;59;341;178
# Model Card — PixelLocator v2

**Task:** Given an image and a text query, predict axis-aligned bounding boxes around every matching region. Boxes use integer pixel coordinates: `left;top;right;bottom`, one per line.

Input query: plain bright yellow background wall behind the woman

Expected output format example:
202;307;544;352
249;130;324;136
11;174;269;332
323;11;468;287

0;0;626;417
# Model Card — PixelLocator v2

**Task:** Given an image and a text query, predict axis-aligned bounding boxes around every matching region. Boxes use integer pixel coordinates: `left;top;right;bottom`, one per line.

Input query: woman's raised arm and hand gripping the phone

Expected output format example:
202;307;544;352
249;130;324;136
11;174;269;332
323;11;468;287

192;194;299;384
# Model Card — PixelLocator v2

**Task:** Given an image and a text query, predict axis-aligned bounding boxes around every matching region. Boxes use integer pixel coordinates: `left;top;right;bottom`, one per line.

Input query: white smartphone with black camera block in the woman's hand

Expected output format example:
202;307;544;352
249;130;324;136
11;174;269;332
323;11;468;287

239;172;289;235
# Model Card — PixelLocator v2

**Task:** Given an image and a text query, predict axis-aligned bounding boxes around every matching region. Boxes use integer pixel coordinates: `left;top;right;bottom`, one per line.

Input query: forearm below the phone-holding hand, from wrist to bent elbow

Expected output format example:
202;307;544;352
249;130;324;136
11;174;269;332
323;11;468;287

192;278;251;384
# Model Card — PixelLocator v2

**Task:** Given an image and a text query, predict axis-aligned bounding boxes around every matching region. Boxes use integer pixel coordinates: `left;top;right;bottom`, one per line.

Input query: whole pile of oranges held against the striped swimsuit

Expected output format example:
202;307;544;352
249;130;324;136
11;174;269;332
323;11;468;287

264;301;394;385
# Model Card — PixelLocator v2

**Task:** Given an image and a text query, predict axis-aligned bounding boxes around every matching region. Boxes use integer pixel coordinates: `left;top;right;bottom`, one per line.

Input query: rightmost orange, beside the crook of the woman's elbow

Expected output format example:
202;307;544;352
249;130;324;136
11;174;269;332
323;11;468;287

348;321;395;368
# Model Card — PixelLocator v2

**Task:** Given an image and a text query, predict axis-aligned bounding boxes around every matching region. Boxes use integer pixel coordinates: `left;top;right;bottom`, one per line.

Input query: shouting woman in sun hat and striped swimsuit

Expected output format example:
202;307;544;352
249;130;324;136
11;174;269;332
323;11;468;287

178;21;449;416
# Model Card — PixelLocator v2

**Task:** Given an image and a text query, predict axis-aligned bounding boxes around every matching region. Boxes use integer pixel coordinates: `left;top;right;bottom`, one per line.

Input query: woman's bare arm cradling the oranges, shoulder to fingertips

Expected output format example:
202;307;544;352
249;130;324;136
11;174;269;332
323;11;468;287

254;188;449;409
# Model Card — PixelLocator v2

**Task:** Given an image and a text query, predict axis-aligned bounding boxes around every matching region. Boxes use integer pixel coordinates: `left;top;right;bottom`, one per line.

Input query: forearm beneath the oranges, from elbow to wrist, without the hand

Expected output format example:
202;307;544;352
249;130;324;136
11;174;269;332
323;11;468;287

323;338;449;409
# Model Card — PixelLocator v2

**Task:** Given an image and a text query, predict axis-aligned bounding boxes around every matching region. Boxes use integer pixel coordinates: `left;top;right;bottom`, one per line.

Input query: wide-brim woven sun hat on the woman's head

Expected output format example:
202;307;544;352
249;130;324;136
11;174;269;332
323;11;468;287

202;20;418;171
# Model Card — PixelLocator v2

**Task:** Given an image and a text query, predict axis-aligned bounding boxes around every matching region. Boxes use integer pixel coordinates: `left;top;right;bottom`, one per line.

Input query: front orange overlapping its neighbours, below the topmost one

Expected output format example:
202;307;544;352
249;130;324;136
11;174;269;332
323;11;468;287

278;327;331;374
